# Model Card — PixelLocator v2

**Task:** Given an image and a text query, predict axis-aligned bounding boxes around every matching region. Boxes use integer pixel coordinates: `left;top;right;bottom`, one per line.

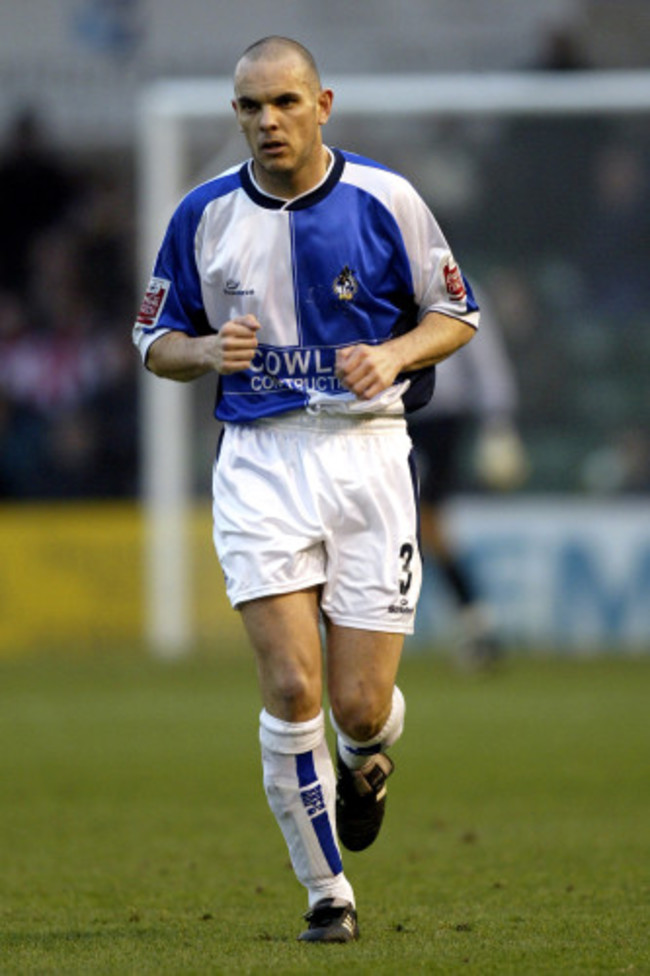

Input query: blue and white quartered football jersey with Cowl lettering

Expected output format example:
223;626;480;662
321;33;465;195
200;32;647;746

133;149;478;423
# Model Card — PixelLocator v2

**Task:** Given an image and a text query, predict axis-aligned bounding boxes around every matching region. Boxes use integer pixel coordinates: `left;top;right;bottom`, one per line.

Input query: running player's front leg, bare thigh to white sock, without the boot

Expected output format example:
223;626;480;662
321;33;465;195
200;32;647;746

242;589;354;908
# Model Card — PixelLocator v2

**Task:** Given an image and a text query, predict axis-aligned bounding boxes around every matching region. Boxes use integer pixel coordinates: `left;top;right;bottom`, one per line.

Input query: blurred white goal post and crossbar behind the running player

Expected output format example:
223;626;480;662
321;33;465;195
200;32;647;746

136;71;650;657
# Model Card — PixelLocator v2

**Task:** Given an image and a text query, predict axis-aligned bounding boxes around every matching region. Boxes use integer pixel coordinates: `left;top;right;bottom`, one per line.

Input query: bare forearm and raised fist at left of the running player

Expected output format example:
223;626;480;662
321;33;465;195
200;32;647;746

147;315;260;382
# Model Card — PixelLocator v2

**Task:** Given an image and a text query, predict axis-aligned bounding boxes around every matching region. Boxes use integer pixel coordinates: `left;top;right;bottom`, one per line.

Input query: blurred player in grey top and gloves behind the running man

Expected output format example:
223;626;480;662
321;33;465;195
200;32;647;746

409;294;528;667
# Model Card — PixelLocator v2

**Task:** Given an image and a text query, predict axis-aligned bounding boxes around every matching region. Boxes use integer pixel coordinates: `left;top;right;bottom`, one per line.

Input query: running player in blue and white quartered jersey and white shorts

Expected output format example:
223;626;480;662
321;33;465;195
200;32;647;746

134;37;478;942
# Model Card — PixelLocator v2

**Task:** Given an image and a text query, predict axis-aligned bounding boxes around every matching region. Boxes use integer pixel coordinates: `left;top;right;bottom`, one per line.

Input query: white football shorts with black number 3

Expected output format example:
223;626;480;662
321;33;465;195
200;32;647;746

213;413;422;634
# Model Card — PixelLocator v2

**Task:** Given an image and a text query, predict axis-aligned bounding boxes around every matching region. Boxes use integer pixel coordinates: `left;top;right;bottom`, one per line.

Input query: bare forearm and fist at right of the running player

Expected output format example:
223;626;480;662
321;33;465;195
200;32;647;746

336;312;476;400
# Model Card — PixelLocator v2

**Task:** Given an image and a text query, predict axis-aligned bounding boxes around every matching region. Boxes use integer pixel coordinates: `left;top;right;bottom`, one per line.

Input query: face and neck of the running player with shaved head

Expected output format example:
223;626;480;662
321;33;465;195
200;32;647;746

232;52;332;197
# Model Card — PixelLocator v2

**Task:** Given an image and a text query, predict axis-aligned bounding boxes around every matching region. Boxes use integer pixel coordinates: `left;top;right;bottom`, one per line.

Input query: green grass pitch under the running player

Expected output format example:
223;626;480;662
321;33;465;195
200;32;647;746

0;648;650;976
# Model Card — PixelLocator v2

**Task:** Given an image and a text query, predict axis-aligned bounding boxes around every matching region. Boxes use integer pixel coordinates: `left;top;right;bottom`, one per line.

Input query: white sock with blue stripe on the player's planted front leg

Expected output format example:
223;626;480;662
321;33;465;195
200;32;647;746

260;709;354;908
